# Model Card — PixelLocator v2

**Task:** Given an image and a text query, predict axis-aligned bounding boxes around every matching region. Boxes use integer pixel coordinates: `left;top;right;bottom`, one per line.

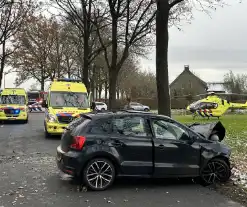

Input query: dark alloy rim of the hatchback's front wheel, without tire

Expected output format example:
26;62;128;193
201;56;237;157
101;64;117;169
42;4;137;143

202;162;227;184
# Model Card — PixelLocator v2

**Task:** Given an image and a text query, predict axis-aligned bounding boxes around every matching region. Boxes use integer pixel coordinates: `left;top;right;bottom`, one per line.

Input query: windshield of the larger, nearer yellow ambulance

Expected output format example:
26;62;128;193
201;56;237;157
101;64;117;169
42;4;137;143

50;91;89;108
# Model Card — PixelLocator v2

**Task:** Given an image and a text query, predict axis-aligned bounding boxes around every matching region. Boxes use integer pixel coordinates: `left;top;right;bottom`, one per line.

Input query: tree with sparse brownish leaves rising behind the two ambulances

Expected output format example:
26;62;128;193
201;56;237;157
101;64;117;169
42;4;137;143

11;15;58;90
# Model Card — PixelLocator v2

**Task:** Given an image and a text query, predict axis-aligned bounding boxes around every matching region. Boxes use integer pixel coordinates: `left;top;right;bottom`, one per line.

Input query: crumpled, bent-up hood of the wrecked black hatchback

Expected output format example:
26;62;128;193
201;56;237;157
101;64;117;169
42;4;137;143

188;121;226;142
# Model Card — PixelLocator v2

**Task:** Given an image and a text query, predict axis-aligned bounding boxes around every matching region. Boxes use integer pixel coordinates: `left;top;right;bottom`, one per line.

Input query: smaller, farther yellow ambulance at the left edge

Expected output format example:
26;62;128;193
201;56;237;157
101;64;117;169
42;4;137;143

0;88;28;123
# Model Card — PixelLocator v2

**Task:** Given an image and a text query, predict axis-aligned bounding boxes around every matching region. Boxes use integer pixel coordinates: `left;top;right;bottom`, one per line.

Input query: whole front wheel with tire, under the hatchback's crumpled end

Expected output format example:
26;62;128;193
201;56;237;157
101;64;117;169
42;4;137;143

200;158;231;186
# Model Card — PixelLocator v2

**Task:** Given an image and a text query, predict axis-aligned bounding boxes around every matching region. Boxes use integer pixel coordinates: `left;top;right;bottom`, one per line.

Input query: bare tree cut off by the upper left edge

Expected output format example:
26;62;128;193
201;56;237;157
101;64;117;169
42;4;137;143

0;0;34;86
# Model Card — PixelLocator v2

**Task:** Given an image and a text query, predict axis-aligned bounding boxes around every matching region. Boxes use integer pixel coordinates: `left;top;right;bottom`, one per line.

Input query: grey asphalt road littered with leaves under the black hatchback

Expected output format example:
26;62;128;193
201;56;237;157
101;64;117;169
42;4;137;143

0;113;244;207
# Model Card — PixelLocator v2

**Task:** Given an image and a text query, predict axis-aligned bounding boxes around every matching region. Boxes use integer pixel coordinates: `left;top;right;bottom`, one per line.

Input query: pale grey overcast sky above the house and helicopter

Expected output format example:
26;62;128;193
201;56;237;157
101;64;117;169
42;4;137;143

3;0;247;89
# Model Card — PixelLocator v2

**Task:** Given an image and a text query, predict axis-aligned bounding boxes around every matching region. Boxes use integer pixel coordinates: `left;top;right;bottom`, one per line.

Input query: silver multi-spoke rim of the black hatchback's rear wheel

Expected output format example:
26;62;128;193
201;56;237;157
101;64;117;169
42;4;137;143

86;161;113;189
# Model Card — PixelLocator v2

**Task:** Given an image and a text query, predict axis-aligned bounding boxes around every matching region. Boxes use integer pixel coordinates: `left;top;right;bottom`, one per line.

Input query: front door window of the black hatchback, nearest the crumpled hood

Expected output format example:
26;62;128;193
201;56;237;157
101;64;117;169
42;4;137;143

152;120;189;140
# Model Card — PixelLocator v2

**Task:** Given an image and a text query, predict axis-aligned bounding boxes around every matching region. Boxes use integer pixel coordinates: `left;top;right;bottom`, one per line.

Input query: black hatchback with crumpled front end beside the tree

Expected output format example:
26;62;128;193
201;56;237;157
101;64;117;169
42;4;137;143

57;110;231;190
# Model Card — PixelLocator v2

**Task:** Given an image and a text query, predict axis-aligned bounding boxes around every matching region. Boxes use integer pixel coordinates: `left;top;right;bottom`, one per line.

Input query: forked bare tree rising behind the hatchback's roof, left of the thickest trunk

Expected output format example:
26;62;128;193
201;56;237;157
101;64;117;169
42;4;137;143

95;0;156;109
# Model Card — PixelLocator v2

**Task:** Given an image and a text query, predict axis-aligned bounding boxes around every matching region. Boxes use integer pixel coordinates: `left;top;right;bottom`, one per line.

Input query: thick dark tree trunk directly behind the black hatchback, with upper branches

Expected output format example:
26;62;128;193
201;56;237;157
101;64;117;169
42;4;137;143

156;0;224;116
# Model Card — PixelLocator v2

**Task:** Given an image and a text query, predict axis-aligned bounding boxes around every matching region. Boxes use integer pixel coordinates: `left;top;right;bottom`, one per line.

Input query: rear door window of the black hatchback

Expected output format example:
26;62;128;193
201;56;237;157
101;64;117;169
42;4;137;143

113;117;147;137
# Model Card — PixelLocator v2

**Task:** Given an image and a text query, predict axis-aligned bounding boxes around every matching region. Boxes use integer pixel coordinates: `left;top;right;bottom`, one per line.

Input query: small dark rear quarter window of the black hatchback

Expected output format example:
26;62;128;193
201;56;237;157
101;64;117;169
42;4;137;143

89;119;111;134
